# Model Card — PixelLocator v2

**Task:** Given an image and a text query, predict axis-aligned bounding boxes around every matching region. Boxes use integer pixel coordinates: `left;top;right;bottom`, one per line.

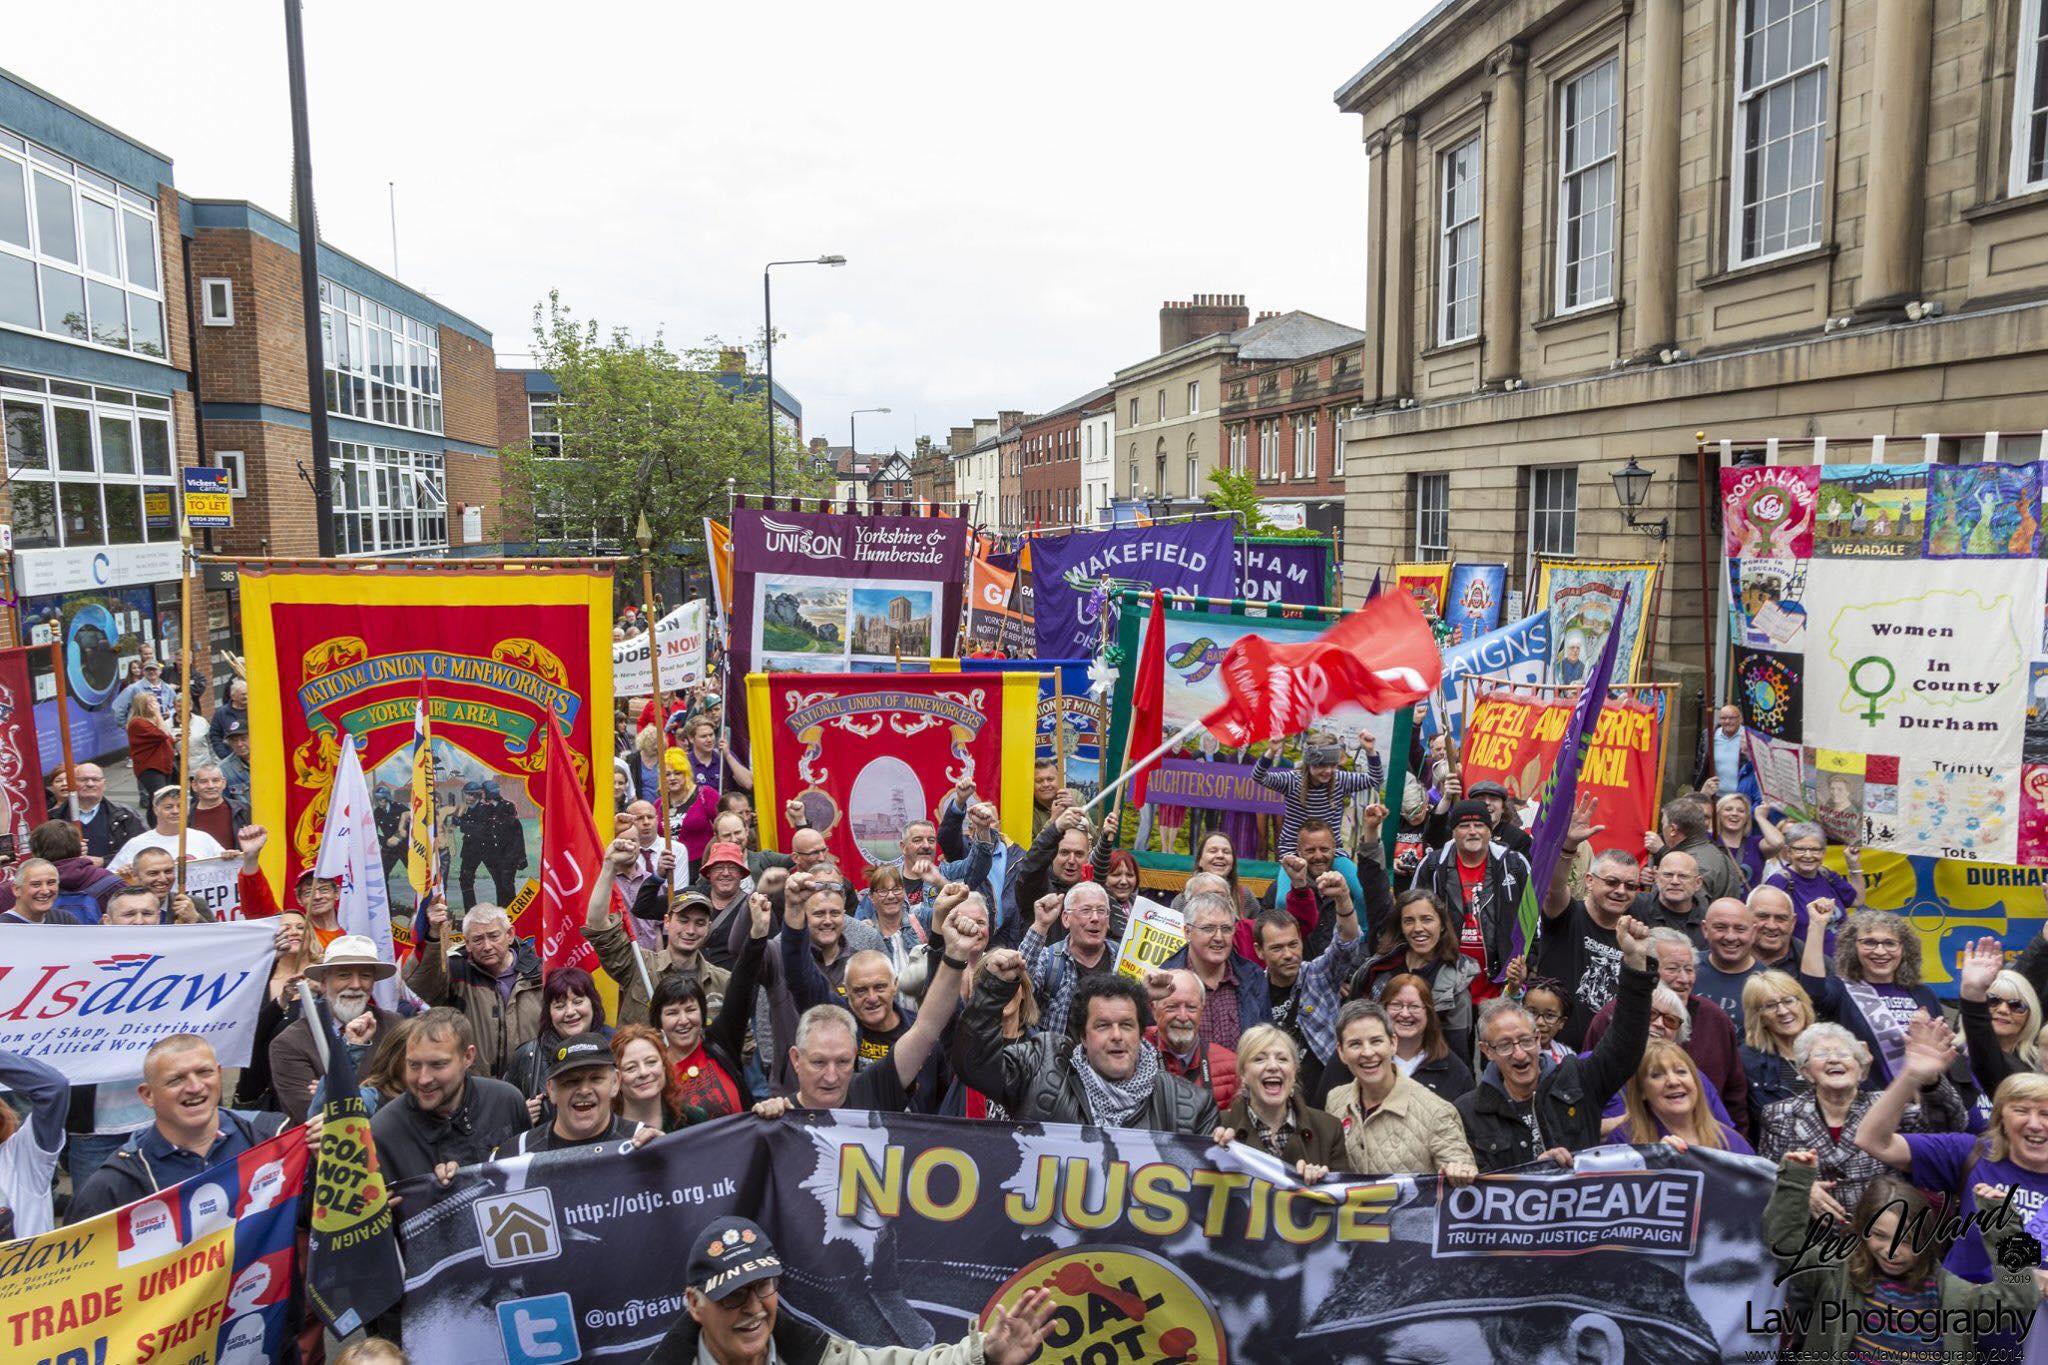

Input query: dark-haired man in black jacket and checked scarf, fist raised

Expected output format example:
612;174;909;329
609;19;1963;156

952;950;1219;1136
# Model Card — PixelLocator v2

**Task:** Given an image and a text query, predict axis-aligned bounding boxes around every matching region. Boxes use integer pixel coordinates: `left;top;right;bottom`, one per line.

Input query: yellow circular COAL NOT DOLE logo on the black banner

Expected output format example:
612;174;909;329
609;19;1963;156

981;1246;1227;1365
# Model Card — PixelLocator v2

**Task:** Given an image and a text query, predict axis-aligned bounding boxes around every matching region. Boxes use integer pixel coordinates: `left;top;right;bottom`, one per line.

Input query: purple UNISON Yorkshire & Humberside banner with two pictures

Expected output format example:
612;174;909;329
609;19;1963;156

729;508;967;687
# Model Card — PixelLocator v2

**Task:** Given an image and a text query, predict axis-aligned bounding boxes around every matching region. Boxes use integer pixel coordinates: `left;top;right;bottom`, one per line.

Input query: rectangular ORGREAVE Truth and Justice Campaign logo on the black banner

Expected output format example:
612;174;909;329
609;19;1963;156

1432;1171;1706;1259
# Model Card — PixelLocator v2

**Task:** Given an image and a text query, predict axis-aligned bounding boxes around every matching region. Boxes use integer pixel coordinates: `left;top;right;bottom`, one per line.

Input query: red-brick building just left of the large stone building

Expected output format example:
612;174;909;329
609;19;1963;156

1221;313;1366;538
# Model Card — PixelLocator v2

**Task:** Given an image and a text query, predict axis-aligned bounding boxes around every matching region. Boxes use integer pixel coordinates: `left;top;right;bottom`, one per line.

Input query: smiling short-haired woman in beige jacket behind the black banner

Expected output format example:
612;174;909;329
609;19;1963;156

1325;1001;1479;1185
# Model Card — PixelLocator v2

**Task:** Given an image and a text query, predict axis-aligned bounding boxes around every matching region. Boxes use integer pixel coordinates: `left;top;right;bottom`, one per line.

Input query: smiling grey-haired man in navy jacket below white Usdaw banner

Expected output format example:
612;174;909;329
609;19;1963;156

63;1033;287;1224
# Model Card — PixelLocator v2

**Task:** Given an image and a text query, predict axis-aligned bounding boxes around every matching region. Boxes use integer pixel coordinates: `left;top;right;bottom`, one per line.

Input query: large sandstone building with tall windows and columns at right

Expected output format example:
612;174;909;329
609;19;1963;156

1337;0;2048;769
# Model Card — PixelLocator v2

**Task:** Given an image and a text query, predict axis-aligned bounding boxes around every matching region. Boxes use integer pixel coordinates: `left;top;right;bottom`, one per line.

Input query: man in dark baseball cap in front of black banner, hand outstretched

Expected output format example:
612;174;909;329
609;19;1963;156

647;1216;1053;1365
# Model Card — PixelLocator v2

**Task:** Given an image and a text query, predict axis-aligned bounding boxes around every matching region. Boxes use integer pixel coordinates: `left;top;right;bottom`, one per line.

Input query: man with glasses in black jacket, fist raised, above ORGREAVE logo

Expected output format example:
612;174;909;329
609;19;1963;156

1456;919;1657;1171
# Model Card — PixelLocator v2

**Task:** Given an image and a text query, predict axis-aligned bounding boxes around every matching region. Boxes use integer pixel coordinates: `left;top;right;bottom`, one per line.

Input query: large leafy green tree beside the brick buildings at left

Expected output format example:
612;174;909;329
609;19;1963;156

500;291;819;571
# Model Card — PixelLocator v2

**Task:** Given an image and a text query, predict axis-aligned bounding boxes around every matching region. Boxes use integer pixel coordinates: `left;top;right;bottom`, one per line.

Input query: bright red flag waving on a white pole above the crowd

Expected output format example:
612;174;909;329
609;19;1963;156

1196;593;1444;749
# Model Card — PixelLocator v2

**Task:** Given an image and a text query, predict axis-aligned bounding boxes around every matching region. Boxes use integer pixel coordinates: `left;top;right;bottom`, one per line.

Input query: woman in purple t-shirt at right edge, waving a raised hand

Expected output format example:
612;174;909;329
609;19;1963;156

1855;1019;2048;1359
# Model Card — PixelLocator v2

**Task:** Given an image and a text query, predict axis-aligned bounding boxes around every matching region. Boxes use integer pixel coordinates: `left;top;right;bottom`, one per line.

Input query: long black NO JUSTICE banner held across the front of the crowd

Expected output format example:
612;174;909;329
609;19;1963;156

399;1111;1784;1365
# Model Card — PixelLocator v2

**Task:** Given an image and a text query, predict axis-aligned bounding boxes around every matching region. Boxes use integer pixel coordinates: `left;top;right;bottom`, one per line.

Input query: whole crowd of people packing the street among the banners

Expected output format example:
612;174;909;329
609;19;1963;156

12;646;2048;1361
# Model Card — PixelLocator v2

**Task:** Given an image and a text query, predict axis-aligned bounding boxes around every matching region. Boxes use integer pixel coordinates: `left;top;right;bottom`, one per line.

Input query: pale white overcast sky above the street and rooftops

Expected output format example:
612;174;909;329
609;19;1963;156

12;0;1427;450
